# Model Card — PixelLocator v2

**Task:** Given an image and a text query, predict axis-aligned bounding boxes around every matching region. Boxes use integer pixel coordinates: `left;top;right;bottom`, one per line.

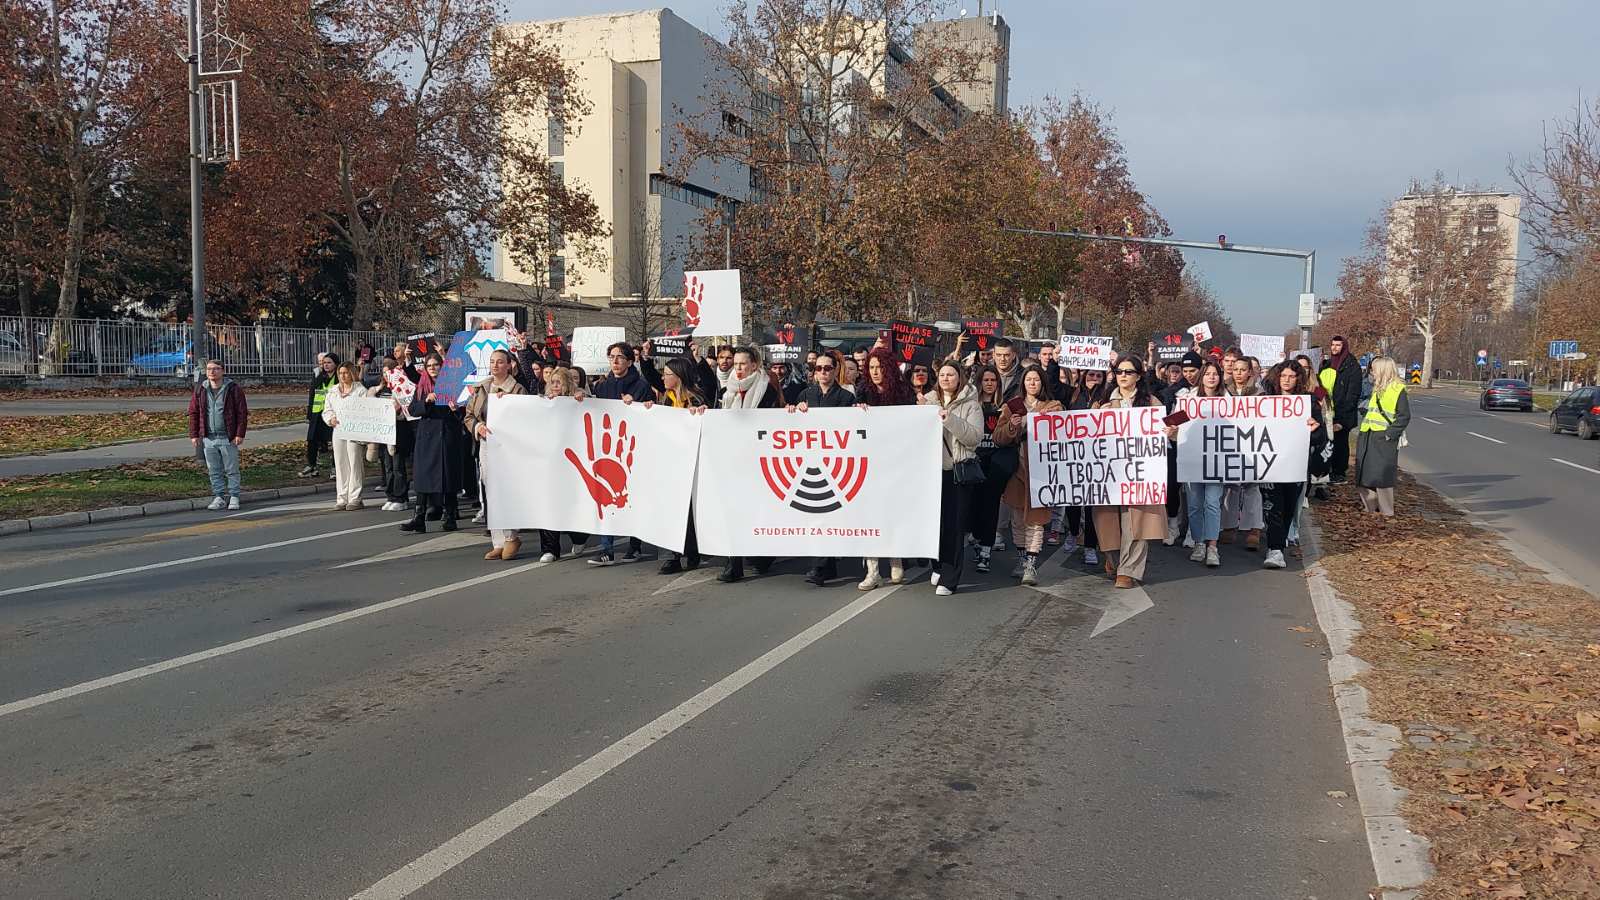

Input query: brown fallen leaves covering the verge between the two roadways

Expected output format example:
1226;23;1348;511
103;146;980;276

1317;476;1600;900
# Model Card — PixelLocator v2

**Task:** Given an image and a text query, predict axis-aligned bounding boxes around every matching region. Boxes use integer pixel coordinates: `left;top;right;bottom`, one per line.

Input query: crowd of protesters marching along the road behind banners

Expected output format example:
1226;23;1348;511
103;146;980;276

190;323;1410;594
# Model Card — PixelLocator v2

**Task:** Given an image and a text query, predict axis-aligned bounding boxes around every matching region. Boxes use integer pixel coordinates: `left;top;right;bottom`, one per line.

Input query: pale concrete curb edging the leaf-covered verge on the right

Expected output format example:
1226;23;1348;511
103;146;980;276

1301;511;1434;900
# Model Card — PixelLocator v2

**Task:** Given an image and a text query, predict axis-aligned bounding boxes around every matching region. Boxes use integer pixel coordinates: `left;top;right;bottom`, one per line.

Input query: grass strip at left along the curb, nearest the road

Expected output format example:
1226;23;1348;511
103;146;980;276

0;442;378;519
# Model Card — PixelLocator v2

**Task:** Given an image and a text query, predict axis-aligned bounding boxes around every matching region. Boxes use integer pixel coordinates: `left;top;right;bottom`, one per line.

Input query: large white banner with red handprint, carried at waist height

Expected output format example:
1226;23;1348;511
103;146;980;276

480;394;704;552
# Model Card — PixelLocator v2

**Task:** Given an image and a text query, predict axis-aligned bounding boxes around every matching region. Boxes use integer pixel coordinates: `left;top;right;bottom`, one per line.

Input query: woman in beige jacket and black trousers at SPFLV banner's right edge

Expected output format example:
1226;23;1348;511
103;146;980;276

928;351;985;596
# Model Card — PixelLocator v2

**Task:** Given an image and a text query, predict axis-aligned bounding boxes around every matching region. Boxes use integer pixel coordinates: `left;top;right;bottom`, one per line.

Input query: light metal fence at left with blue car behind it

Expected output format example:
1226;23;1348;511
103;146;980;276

0;315;395;378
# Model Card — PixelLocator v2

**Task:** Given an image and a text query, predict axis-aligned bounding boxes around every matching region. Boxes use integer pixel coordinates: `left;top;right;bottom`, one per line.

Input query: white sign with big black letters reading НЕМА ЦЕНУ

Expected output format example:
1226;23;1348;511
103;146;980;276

1173;394;1310;484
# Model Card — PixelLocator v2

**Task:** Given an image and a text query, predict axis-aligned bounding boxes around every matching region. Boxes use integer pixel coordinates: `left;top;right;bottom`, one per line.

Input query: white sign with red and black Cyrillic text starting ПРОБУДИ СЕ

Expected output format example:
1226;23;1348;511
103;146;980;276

1022;407;1166;506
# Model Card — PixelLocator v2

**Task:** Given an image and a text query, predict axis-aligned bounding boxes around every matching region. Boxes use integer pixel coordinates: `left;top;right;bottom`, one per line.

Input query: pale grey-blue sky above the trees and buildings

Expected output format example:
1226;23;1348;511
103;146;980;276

510;0;1600;333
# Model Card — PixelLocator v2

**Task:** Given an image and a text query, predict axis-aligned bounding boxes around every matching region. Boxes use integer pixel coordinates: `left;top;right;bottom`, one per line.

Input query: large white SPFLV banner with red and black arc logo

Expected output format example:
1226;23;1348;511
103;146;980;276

694;407;942;557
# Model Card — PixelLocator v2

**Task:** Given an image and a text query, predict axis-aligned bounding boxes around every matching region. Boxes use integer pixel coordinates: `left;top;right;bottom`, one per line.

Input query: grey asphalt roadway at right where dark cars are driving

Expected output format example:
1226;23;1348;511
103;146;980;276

1400;388;1600;594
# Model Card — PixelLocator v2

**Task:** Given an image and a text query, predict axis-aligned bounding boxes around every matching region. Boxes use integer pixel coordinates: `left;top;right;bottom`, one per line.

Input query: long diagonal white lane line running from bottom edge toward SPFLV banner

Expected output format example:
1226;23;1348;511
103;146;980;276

352;573;904;900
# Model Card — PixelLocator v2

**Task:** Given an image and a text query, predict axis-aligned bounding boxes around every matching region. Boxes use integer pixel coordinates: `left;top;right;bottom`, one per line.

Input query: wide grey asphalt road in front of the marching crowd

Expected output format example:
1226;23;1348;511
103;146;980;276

0;490;1376;900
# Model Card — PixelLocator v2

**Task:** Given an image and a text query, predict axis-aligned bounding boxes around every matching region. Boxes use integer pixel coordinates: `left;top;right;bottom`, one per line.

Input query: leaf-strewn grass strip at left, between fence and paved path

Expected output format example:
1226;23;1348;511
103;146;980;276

0;407;306;456
